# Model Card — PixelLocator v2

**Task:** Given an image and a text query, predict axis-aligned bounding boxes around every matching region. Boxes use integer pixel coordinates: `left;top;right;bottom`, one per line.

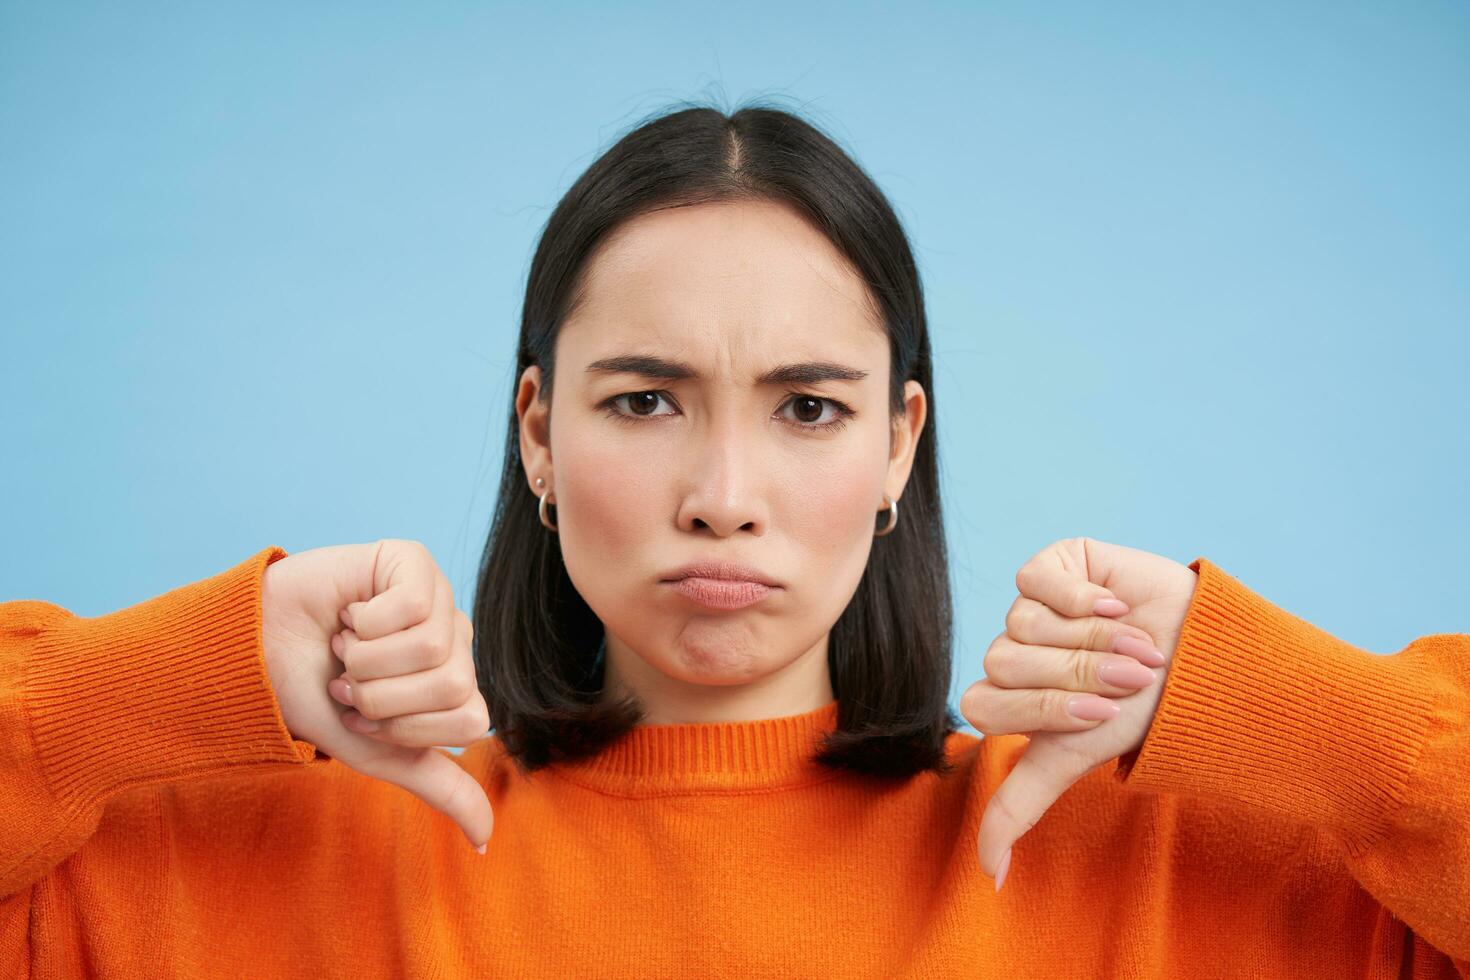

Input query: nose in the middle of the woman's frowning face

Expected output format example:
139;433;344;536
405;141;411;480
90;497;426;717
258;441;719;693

679;411;770;538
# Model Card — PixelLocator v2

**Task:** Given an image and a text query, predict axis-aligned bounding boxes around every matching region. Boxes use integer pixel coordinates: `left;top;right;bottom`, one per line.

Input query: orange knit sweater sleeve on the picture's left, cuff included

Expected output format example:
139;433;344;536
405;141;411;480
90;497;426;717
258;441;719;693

0;547;332;910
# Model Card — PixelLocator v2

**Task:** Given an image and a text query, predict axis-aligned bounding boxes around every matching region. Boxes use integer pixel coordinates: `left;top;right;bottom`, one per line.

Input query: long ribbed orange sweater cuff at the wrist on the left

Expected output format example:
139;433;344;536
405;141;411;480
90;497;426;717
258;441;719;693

25;547;331;801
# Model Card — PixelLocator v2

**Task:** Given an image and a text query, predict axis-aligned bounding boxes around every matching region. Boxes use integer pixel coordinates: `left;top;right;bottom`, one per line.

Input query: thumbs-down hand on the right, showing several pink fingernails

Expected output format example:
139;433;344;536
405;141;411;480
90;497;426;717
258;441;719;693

960;538;1198;890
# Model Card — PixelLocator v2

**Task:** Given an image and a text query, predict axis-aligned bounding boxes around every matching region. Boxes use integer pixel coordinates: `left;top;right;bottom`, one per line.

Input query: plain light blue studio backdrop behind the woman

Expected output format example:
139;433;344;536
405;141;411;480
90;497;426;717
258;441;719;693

0;0;1470;734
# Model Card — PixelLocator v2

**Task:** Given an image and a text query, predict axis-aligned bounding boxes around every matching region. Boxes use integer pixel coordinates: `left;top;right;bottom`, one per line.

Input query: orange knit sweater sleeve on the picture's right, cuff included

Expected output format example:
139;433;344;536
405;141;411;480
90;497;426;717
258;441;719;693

1114;558;1470;977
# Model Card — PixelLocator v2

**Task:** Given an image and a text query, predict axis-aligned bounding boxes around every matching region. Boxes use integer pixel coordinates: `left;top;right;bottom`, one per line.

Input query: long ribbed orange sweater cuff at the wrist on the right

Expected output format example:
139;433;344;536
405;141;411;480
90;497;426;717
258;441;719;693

1116;558;1432;849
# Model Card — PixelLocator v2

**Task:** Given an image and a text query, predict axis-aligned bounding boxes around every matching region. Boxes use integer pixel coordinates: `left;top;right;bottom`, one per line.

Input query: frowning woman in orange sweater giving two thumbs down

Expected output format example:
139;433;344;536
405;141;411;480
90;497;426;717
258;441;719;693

0;106;1470;979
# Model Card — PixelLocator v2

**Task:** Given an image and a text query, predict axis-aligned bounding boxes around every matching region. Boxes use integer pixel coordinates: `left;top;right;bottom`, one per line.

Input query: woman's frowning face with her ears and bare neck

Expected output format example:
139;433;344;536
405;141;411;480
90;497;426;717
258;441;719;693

516;201;926;724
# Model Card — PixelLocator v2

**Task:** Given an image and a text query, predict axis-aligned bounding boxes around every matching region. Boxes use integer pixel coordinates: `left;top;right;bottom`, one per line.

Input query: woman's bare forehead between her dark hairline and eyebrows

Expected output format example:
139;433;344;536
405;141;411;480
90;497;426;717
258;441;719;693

559;201;886;373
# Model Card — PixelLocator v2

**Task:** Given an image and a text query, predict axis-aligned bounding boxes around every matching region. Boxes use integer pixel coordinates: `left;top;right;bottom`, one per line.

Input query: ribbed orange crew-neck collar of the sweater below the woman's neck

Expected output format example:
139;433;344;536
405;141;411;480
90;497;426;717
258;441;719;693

548;699;841;796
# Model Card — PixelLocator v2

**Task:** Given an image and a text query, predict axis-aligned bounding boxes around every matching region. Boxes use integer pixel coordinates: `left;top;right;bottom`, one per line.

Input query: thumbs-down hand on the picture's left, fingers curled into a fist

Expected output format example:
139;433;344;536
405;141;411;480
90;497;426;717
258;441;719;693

262;538;494;848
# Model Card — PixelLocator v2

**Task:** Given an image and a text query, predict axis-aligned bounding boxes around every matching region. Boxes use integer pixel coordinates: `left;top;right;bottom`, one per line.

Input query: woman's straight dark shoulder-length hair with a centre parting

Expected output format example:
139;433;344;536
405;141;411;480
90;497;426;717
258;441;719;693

472;103;958;777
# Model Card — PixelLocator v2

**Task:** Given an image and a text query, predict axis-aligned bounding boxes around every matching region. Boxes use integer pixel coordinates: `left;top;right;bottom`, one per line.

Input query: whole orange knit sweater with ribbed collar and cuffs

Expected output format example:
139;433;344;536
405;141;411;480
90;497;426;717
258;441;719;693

0;548;1470;980
